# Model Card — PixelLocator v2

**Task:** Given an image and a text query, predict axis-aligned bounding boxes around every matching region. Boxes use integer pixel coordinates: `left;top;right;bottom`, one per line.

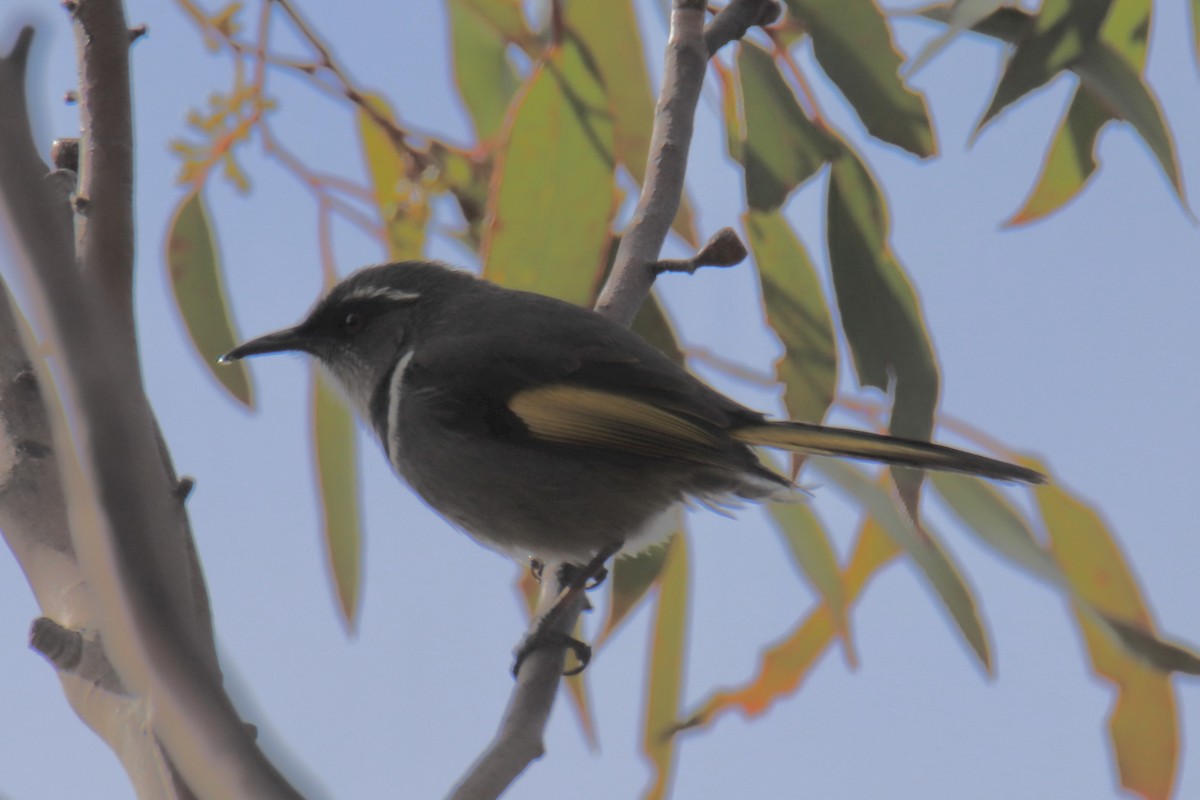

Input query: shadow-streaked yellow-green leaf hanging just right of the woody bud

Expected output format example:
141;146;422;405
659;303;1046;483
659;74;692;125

743;210;838;422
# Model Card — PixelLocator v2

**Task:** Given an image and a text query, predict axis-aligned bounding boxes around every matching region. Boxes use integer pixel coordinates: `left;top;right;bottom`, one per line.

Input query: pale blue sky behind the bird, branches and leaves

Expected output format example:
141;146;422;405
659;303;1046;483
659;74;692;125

0;0;1200;800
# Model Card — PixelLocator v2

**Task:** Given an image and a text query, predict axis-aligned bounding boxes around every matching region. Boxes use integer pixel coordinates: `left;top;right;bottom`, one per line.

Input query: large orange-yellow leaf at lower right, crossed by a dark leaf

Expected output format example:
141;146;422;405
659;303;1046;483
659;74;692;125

1036;465;1178;800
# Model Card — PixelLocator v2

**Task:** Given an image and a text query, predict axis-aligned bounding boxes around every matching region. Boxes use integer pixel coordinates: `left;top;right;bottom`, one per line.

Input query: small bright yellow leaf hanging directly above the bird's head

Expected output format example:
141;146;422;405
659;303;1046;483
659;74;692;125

355;95;432;261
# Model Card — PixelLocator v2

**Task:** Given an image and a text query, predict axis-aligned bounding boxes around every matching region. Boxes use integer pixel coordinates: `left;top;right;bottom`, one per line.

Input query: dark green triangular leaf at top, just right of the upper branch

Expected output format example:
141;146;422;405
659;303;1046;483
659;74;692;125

738;42;838;210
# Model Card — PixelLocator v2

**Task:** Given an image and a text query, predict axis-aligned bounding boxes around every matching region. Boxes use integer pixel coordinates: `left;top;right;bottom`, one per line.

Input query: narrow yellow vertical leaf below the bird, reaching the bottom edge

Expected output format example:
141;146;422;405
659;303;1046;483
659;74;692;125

642;536;689;800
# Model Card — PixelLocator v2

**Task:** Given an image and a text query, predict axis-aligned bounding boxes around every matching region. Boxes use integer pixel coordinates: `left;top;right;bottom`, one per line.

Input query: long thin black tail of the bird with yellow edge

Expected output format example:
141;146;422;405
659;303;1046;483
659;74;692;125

731;422;1046;483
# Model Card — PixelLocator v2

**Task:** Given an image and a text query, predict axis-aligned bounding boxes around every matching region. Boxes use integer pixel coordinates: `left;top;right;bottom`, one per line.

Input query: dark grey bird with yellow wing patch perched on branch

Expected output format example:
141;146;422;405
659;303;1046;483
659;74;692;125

221;261;1045;567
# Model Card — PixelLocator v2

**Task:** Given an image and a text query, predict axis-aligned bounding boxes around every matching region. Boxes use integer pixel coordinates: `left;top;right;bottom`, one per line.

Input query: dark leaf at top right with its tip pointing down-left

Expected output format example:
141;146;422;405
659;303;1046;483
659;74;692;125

974;0;1112;136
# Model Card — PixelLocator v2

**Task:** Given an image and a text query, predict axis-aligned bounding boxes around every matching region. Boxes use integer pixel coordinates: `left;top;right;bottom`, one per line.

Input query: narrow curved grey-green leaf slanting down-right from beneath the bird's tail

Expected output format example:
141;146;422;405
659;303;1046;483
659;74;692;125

812;458;991;674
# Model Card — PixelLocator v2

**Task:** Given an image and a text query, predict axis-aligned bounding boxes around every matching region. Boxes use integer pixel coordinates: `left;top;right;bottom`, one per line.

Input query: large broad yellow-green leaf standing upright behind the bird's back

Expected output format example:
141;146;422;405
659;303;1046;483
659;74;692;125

484;36;616;305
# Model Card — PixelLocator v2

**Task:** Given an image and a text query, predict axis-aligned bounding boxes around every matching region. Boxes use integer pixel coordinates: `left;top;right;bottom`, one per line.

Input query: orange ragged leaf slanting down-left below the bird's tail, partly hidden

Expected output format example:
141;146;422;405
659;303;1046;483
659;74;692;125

680;517;900;728
